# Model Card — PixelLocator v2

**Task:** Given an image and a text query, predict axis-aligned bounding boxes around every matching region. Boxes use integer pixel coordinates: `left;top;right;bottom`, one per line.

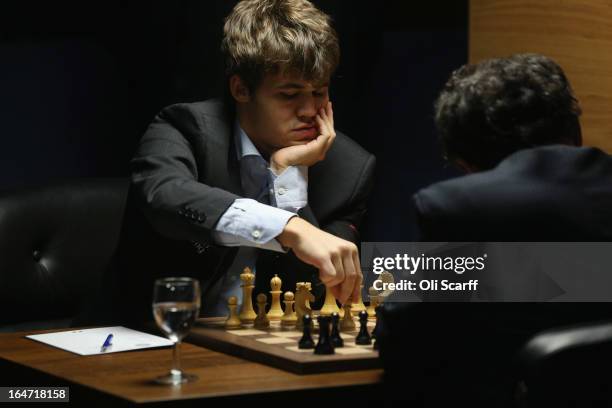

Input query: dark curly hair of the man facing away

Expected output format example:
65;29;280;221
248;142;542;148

435;54;582;170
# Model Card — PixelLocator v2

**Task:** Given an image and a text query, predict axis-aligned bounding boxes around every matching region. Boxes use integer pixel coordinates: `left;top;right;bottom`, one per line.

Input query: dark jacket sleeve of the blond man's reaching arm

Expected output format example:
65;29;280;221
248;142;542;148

131;104;240;243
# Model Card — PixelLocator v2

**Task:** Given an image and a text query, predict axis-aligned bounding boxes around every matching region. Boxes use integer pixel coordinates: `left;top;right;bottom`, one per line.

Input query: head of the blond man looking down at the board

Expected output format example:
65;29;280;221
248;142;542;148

221;0;340;154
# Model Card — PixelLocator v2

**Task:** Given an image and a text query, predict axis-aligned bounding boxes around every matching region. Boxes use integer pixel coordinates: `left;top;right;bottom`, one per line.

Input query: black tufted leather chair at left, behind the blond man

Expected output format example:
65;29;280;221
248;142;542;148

0;178;129;331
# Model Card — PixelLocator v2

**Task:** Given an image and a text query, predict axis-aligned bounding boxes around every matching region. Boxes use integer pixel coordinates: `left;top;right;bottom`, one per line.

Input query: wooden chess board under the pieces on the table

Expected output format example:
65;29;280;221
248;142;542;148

186;318;380;374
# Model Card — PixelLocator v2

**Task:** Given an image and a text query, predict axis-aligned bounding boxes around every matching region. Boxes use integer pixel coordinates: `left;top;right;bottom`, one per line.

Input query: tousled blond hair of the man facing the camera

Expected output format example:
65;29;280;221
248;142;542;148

221;0;340;91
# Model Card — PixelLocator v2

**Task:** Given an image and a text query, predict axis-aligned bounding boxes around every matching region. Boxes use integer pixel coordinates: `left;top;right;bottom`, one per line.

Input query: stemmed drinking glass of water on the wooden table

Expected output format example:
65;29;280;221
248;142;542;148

153;278;200;385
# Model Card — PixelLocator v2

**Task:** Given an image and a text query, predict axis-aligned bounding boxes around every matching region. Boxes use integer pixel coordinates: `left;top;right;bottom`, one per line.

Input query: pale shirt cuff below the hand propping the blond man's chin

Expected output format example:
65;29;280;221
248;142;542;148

270;166;308;213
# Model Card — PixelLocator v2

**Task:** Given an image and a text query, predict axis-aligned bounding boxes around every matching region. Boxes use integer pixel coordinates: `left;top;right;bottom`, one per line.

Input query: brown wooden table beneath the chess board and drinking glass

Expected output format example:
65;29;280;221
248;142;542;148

0;332;382;408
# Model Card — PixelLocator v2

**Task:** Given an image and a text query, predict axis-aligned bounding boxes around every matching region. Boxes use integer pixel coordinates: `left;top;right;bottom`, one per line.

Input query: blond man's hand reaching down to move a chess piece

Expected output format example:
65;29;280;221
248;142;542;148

277;217;363;303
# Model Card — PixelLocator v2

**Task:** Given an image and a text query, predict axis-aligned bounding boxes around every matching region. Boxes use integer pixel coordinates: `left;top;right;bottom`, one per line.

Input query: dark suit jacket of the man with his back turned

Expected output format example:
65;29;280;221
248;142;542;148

379;146;612;407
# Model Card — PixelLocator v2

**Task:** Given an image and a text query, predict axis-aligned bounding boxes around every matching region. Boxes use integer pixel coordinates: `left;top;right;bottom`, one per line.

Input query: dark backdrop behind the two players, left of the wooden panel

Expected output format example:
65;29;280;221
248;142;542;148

0;0;468;241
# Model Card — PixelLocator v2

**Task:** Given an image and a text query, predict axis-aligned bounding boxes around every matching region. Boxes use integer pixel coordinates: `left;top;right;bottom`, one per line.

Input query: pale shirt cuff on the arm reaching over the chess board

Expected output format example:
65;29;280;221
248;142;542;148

213;198;295;252
